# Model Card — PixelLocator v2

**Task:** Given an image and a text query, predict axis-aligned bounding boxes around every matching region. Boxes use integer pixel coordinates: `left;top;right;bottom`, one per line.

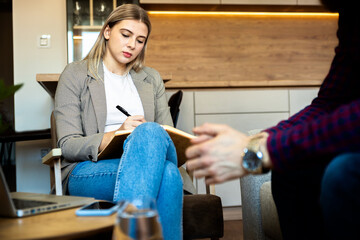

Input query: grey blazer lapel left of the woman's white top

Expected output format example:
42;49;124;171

88;61;107;133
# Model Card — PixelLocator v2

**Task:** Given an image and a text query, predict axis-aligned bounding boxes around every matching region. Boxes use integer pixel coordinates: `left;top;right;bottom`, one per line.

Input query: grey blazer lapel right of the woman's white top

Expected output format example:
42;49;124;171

130;70;155;122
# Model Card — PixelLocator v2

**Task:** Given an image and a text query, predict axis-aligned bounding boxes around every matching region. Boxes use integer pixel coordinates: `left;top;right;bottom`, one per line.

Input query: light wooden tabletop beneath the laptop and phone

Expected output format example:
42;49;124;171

0;208;116;240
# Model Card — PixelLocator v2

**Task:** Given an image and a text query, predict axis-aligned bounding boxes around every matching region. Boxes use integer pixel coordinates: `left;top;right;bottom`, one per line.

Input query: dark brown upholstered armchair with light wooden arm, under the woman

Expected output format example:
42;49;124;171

42;90;224;240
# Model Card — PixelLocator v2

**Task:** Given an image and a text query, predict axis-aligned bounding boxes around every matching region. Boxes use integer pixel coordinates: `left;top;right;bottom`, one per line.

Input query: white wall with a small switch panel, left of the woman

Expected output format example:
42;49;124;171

13;0;67;192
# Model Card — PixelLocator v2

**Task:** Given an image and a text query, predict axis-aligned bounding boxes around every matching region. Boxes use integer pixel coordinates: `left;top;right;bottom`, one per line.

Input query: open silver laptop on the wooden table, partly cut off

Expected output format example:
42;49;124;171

0;165;95;217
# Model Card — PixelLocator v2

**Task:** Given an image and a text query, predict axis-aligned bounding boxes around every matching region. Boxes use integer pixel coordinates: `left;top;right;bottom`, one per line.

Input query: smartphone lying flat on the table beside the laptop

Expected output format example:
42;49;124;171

75;201;118;216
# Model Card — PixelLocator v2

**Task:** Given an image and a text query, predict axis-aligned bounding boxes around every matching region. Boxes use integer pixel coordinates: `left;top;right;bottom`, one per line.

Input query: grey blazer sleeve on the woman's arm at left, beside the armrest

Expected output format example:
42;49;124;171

54;64;103;162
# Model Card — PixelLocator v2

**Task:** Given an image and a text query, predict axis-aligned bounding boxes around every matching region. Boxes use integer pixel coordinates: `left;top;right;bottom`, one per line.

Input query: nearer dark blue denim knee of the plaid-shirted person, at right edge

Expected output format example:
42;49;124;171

320;153;360;239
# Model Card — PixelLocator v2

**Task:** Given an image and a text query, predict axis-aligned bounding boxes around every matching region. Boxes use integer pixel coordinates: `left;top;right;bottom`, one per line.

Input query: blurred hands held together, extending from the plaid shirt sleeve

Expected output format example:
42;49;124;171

186;123;250;184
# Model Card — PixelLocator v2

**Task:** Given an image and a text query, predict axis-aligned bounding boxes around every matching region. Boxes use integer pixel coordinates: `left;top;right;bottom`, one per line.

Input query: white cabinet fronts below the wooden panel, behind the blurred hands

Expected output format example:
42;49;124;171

167;87;318;207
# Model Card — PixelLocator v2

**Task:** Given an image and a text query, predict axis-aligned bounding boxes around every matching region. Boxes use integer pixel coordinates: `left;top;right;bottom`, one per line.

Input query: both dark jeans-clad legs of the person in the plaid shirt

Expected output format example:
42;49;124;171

271;153;360;240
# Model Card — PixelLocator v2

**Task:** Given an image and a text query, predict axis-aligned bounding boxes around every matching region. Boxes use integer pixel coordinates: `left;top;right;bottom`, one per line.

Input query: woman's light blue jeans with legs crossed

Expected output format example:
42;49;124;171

68;122;183;240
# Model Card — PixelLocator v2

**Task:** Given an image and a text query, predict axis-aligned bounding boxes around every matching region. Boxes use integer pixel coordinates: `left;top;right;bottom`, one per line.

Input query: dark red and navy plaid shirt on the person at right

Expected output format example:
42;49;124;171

265;9;360;171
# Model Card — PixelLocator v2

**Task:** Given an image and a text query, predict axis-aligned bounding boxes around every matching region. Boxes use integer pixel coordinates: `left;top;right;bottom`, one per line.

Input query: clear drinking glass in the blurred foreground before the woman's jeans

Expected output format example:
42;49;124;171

113;198;163;240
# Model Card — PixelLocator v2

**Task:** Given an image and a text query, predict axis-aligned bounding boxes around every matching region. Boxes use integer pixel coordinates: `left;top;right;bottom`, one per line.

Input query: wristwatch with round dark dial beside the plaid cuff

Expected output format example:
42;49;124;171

242;134;270;174
